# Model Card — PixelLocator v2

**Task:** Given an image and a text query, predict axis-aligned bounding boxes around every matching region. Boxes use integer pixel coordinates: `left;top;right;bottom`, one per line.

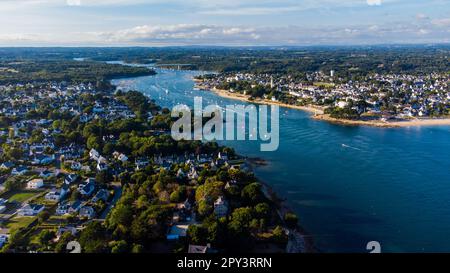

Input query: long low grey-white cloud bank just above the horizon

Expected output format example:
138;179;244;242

81;22;450;46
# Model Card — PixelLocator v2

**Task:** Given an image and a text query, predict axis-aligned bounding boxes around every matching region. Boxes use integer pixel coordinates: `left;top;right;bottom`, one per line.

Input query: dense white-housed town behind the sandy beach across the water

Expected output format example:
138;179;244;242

196;70;450;125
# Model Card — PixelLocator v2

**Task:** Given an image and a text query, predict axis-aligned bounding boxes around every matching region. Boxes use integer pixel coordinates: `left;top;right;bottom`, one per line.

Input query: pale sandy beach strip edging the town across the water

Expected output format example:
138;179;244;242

198;83;450;128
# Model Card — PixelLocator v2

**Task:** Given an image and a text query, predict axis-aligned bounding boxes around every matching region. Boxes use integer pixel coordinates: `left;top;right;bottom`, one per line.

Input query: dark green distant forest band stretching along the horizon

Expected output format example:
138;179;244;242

0;45;450;79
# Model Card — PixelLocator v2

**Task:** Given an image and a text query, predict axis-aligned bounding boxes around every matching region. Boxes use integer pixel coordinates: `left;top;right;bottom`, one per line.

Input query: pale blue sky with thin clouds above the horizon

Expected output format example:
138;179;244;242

0;0;450;46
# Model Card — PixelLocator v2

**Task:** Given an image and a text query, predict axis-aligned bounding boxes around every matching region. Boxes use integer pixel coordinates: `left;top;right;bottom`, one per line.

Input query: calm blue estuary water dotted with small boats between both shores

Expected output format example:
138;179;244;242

114;65;450;252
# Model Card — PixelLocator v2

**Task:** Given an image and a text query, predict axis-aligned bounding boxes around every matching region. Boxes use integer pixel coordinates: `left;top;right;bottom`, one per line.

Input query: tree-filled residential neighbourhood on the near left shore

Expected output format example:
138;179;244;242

0;79;307;253
